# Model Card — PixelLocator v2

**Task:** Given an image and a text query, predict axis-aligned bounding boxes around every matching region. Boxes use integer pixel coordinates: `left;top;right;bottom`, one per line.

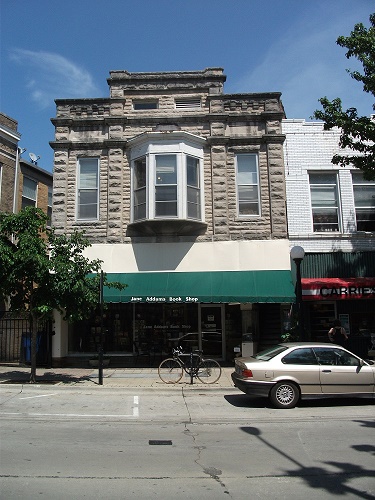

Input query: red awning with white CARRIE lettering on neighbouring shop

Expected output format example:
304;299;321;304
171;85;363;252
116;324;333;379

302;278;375;300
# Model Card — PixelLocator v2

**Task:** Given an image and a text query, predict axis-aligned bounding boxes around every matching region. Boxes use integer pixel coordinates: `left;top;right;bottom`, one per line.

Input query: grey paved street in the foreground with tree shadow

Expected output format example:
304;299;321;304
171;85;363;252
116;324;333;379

0;383;375;500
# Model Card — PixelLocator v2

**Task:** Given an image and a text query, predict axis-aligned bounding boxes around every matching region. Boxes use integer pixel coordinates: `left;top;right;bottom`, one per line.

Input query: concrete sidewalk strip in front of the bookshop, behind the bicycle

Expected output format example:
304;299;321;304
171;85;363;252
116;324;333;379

0;365;234;389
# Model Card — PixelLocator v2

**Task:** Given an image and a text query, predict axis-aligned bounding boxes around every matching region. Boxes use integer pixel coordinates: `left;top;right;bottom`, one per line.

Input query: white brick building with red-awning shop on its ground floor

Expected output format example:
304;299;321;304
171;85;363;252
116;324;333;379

282;119;375;354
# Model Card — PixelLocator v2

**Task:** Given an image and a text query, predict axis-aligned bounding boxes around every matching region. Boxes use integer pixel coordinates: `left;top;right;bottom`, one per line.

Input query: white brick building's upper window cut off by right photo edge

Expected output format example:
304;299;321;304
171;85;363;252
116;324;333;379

352;172;375;231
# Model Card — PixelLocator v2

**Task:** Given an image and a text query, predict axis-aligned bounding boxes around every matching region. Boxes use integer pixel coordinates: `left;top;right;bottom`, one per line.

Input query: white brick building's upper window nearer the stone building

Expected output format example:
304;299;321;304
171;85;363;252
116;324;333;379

309;173;340;232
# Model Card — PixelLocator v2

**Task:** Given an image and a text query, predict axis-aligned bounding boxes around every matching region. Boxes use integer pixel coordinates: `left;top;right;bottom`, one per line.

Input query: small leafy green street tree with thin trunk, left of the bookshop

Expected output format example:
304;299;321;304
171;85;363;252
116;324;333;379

0;207;126;382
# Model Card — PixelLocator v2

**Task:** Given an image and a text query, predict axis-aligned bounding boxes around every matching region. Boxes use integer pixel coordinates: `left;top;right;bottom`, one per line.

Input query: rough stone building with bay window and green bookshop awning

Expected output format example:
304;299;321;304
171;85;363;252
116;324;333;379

51;68;294;363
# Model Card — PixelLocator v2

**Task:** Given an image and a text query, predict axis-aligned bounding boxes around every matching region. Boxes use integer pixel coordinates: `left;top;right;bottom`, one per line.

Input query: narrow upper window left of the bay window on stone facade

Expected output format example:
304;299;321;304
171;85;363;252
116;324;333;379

77;158;99;220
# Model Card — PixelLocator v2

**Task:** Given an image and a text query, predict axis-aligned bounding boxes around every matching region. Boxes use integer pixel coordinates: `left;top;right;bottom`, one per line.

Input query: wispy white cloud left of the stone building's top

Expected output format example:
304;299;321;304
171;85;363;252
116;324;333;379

11;49;99;109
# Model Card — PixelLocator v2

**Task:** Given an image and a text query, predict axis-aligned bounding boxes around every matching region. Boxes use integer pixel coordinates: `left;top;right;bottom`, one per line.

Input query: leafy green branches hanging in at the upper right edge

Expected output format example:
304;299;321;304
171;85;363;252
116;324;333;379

314;13;375;180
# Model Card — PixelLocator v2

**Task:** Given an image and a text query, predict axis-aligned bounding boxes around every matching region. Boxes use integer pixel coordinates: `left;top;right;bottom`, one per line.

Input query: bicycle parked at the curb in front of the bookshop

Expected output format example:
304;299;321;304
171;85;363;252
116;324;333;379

158;347;221;384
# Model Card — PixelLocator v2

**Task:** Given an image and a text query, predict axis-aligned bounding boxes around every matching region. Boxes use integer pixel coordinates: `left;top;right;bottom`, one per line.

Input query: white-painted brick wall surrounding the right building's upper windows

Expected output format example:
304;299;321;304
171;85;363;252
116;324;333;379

282;120;374;252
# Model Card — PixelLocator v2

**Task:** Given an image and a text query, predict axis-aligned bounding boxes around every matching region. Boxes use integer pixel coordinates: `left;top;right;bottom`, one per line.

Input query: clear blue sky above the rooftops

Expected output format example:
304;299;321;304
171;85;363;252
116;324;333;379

0;0;375;171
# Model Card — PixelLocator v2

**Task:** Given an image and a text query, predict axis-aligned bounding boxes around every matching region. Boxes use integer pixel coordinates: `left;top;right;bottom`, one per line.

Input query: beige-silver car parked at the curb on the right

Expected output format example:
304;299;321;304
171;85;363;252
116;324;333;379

232;342;375;408
